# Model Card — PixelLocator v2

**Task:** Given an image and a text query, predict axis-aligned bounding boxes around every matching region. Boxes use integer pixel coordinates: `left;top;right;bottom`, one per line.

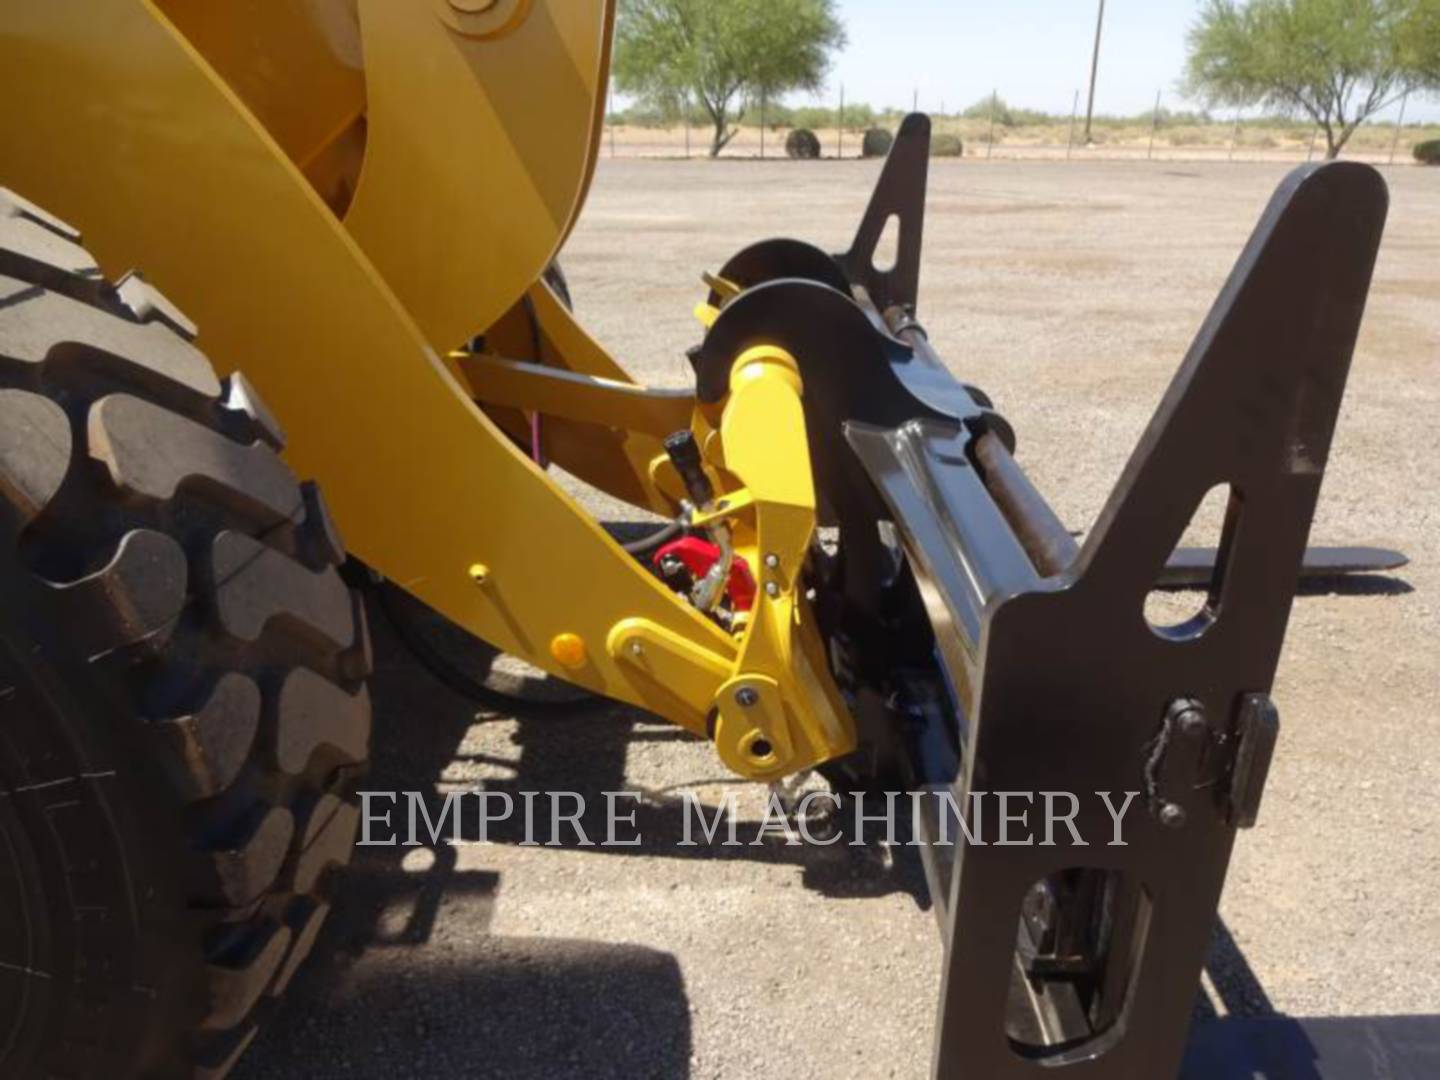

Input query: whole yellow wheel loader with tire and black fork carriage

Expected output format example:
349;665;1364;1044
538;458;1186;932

0;0;1387;1080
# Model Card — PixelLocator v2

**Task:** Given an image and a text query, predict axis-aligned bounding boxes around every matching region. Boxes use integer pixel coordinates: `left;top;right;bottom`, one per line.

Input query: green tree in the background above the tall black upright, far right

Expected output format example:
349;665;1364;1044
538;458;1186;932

1185;0;1440;158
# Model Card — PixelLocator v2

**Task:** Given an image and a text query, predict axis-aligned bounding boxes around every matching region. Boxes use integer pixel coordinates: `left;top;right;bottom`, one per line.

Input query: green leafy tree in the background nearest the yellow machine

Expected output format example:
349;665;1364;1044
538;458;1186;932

615;0;845;157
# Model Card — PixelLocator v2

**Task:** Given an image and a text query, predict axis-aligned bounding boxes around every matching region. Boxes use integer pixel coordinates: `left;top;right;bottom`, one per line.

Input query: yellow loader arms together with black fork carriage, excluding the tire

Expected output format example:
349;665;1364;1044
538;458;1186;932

0;0;1398;1080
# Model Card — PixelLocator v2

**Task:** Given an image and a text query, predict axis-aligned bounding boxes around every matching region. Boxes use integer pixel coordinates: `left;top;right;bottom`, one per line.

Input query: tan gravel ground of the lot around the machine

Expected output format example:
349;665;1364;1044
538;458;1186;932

238;160;1440;1080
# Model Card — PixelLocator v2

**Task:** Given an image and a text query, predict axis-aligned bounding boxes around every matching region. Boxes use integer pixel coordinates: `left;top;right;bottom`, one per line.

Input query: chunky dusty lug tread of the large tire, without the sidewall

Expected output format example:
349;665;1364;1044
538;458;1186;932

0;189;370;1080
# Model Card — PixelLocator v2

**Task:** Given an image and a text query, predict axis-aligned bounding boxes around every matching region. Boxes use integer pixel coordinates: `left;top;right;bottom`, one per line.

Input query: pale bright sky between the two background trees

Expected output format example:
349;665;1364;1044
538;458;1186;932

792;0;1440;120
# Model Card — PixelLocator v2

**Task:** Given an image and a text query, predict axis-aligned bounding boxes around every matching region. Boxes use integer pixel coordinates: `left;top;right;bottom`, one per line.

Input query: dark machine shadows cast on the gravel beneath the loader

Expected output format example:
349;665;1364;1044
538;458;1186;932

235;593;1440;1080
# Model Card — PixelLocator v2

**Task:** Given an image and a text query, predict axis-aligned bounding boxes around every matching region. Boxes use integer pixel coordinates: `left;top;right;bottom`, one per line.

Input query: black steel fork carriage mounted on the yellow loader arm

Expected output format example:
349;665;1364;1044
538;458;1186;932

691;115;1388;1080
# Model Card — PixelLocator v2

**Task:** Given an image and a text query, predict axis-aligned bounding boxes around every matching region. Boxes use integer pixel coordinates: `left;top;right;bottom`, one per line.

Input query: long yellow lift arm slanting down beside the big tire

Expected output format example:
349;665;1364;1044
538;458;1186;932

0;0;736;704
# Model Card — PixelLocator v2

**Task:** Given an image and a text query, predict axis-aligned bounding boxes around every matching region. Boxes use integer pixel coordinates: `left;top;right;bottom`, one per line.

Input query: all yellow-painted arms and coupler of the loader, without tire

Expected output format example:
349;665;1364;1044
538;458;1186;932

0;0;854;779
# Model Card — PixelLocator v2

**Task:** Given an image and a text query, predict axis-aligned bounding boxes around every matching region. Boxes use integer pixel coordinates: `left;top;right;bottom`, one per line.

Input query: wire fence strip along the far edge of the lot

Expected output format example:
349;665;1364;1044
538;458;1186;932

605;88;1440;166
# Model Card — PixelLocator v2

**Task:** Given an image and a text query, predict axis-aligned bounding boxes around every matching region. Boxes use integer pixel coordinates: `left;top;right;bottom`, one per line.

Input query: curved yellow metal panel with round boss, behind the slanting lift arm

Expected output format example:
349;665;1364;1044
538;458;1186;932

346;0;613;350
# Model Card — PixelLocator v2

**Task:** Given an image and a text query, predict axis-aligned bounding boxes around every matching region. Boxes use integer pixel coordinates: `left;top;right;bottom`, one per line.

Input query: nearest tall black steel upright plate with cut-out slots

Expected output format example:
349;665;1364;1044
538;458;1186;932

848;163;1387;1080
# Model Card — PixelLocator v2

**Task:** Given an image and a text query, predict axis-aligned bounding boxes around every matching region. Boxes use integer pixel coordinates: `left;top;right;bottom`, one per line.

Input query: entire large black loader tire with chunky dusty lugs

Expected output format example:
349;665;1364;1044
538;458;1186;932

0;189;370;1080
